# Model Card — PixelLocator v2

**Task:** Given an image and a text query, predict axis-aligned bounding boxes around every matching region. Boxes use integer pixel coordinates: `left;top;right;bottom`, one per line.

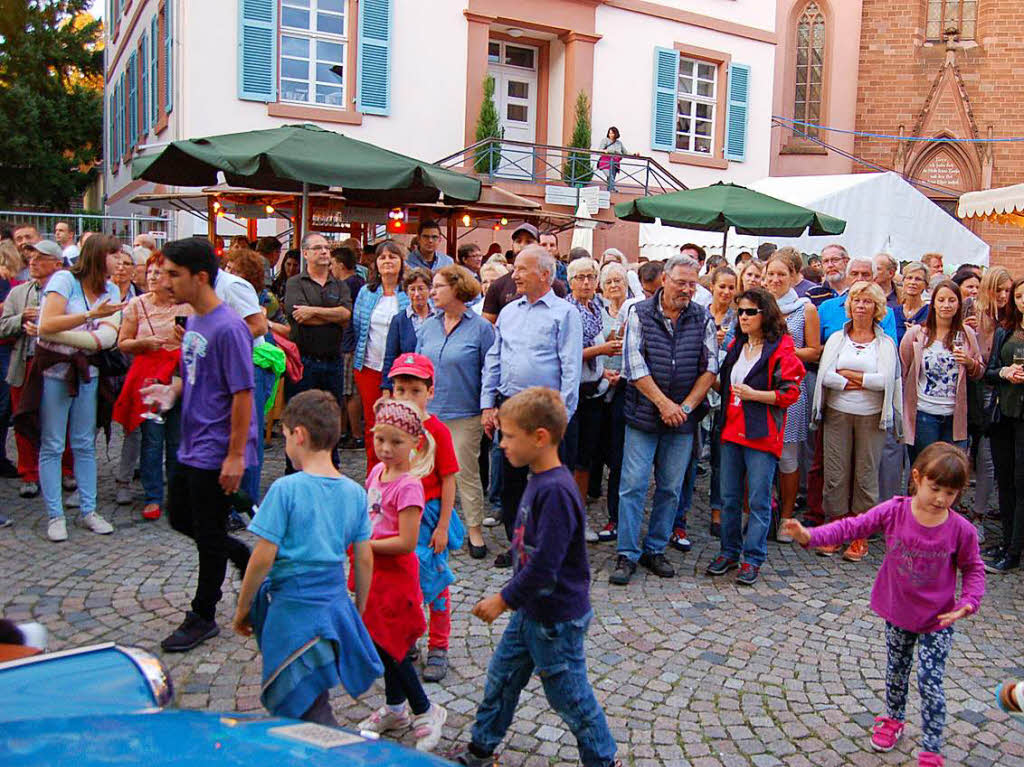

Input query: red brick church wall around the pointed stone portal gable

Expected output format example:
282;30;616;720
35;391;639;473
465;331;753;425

854;0;1024;275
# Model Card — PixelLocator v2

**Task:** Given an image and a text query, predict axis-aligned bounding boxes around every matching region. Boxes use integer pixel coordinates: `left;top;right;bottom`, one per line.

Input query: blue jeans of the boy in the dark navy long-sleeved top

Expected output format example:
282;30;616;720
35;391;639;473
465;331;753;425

472;610;615;767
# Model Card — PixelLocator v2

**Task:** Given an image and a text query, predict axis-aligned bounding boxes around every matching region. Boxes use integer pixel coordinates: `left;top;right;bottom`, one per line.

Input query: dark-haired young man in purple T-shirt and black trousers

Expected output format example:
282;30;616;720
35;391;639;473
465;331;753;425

141;238;258;652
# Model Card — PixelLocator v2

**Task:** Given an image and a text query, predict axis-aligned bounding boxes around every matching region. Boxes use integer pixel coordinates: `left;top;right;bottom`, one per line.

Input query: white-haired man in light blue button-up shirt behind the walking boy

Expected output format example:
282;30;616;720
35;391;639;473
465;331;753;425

480;245;583;567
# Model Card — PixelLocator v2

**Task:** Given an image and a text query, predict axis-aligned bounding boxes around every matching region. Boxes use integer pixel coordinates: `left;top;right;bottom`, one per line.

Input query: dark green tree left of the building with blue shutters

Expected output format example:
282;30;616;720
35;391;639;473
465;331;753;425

0;0;103;209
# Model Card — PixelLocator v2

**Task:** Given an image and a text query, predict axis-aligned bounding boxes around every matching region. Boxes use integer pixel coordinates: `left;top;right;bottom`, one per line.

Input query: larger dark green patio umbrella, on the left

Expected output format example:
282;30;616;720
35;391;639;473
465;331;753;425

132;124;480;239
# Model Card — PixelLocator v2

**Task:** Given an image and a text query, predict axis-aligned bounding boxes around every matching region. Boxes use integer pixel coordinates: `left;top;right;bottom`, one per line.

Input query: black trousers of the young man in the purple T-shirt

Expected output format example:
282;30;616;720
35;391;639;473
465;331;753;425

167;464;249;621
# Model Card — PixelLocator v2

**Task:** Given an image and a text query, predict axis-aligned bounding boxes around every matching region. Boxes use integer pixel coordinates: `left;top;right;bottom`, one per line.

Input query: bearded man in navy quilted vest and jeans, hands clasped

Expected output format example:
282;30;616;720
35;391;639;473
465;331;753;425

608;256;718;586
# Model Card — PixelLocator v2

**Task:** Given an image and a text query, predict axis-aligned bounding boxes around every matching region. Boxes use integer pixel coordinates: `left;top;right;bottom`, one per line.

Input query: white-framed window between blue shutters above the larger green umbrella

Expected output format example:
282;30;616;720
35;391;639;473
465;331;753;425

280;0;348;106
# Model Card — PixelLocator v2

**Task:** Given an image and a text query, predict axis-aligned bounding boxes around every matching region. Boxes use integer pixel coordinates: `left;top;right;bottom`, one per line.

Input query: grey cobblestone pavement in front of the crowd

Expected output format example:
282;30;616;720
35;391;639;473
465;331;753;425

0;428;1024;767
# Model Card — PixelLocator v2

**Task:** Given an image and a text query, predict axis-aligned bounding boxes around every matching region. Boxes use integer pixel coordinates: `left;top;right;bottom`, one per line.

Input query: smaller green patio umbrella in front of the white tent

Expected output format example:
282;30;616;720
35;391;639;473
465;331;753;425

615;182;846;253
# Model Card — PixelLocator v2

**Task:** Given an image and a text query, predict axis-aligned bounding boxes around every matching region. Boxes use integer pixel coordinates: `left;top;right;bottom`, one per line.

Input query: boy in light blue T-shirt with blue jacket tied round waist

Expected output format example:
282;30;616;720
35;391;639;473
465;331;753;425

232;389;384;725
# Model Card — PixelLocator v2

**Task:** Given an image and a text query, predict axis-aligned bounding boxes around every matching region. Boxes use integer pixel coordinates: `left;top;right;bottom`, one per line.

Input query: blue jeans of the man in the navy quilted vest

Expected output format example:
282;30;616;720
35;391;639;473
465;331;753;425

618;425;693;562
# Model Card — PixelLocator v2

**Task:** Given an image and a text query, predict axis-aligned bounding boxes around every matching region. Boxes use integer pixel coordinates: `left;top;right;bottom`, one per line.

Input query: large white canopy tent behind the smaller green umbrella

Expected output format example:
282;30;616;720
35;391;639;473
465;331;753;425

640;172;989;267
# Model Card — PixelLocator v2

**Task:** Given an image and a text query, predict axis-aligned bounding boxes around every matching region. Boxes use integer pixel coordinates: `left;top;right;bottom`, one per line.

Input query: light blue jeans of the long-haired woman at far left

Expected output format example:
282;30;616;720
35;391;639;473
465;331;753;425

39;376;99;519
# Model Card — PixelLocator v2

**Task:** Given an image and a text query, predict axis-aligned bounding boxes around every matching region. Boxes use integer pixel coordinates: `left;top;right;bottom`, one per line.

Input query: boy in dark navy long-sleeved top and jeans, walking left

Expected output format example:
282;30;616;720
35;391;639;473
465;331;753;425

452;386;621;767
